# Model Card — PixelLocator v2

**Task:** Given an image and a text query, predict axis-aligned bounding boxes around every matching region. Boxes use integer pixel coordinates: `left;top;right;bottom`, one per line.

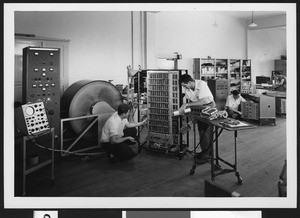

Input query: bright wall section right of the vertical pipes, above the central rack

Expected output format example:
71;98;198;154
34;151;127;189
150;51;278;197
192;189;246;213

147;11;247;75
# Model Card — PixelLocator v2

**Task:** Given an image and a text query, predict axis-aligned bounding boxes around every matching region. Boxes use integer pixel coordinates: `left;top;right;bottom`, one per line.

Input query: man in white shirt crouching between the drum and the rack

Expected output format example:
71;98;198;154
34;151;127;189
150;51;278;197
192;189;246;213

100;104;147;163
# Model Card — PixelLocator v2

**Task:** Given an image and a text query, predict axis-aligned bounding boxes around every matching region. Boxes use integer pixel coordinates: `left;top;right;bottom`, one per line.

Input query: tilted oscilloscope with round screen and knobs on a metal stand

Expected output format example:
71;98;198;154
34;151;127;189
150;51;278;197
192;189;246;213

16;102;50;135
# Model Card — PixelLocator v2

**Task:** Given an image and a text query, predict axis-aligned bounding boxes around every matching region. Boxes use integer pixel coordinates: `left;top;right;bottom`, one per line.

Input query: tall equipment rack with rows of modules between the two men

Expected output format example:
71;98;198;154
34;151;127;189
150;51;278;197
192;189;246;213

147;70;187;157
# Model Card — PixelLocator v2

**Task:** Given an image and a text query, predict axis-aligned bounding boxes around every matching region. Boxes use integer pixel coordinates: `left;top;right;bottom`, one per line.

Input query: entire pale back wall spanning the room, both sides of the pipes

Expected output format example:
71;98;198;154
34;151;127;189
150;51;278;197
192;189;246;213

15;11;286;84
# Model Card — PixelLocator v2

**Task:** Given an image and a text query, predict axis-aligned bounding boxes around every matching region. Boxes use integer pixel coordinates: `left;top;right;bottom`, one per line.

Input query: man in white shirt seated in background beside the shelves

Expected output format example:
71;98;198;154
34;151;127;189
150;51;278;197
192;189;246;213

225;90;246;119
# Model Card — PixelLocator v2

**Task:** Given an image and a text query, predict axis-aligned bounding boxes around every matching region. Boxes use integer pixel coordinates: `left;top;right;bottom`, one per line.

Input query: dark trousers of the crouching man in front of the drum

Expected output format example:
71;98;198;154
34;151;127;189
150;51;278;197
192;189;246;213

102;128;138;161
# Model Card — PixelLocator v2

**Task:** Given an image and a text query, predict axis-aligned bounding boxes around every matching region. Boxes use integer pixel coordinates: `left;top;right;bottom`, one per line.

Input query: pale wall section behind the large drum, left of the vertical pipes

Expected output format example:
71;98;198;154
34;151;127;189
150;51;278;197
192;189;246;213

15;11;141;84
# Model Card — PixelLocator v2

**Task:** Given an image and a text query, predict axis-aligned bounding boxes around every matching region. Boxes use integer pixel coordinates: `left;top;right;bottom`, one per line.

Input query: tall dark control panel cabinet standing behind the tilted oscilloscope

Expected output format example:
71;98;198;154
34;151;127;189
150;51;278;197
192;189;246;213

23;47;60;139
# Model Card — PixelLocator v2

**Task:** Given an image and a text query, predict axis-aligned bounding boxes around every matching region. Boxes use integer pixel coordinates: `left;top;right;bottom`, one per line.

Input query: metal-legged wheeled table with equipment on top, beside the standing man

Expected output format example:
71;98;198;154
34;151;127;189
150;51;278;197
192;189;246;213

189;116;256;184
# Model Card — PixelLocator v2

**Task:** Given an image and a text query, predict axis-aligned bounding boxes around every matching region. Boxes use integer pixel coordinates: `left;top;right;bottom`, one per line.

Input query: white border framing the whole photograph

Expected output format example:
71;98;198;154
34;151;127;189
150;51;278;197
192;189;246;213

3;3;297;209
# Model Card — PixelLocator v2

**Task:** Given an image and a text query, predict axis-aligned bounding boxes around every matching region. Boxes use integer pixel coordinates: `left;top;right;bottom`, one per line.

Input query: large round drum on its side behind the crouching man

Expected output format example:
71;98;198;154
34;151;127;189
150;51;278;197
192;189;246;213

61;80;122;138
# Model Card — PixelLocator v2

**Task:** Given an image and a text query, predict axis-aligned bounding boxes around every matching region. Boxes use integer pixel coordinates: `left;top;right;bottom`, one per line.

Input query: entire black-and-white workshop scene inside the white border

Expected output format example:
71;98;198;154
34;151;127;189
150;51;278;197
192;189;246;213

9;4;296;204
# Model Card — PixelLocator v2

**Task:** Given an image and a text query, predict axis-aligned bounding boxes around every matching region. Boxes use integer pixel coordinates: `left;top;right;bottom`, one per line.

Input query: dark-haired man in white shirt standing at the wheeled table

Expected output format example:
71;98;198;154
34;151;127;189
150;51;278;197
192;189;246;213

179;74;216;164
